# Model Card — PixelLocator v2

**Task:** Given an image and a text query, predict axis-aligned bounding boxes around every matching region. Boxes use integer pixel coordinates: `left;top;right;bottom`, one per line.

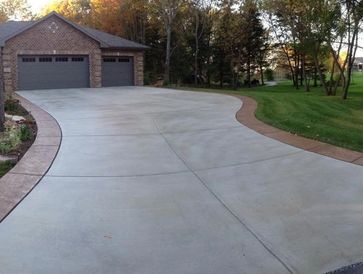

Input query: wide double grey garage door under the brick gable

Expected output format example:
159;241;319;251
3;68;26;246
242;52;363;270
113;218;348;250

18;55;89;90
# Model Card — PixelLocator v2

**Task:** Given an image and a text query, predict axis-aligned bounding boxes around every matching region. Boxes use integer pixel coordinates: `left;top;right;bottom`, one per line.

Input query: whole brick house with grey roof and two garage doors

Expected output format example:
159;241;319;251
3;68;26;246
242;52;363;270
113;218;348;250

0;12;147;94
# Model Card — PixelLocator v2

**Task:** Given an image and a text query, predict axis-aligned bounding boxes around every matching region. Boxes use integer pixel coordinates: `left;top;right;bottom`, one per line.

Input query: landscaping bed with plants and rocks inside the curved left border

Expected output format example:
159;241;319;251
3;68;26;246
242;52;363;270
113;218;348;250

0;99;37;177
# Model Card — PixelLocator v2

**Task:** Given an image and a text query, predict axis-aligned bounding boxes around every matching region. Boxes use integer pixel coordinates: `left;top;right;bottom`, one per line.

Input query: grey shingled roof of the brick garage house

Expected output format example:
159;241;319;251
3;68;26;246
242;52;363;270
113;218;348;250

0;12;149;50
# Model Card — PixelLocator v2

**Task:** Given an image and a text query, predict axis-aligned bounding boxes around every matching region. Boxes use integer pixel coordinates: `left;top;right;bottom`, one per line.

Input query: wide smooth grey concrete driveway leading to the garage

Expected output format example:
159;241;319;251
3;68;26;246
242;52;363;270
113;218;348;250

0;87;363;274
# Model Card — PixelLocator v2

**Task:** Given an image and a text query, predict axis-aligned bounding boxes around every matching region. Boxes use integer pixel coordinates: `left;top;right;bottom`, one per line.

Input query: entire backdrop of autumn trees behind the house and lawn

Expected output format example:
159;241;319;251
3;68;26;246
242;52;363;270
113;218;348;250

0;0;363;98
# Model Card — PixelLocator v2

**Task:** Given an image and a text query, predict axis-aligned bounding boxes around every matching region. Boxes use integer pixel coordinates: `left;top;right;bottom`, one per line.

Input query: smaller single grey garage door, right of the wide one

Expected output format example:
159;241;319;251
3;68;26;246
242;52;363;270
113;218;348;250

102;57;134;87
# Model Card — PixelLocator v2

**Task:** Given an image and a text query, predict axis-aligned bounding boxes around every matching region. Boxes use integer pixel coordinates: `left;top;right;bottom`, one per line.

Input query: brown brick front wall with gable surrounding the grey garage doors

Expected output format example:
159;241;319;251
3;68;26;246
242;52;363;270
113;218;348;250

3;15;144;94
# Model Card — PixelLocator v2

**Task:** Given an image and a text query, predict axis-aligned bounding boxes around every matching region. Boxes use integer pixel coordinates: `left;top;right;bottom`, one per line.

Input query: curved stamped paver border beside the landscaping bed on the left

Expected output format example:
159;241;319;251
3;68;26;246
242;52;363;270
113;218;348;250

0;95;62;223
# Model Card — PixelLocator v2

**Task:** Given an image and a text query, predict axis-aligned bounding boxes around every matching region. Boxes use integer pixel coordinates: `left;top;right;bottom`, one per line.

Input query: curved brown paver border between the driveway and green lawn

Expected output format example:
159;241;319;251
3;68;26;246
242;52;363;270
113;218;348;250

235;95;363;166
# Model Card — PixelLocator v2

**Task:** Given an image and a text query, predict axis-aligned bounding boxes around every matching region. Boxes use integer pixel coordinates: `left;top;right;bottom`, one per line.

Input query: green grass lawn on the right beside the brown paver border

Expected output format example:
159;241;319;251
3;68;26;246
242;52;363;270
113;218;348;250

178;74;363;152
